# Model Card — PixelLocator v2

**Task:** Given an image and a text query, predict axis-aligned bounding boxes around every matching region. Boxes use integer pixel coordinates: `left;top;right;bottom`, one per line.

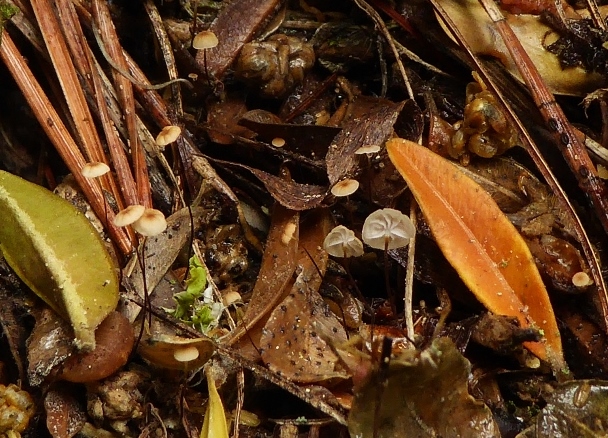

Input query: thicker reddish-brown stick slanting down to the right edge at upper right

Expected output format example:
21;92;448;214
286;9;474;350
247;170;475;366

479;0;608;238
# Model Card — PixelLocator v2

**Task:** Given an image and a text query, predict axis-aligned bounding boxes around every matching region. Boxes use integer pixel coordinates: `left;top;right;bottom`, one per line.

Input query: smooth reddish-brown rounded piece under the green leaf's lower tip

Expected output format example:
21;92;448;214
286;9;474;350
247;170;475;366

59;311;135;383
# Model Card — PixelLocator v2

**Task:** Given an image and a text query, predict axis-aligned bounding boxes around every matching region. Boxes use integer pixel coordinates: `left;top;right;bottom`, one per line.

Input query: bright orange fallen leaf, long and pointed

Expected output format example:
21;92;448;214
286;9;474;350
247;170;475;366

386;138;566;372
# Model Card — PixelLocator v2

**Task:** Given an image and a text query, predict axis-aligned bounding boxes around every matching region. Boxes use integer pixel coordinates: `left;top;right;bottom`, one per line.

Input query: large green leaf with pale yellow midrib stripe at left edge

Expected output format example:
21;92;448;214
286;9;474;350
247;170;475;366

0;171;118;350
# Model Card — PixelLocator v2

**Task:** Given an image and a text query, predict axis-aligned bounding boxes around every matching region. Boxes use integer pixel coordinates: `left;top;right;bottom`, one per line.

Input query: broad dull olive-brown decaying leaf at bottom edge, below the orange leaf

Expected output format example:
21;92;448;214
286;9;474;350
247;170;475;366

348;338;500;438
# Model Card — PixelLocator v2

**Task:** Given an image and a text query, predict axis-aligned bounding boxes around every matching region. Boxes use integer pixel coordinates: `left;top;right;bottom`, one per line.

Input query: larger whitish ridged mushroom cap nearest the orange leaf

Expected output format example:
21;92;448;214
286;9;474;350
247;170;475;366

361;208;416;249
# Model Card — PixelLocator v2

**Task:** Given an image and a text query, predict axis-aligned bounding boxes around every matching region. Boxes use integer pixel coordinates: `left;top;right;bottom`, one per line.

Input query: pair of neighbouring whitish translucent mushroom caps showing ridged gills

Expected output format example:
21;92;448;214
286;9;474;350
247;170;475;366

323;208;416;257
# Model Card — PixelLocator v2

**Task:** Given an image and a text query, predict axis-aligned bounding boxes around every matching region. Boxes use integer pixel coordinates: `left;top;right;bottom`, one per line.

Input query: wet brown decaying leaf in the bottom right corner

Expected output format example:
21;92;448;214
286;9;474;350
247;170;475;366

518;380;608;438
